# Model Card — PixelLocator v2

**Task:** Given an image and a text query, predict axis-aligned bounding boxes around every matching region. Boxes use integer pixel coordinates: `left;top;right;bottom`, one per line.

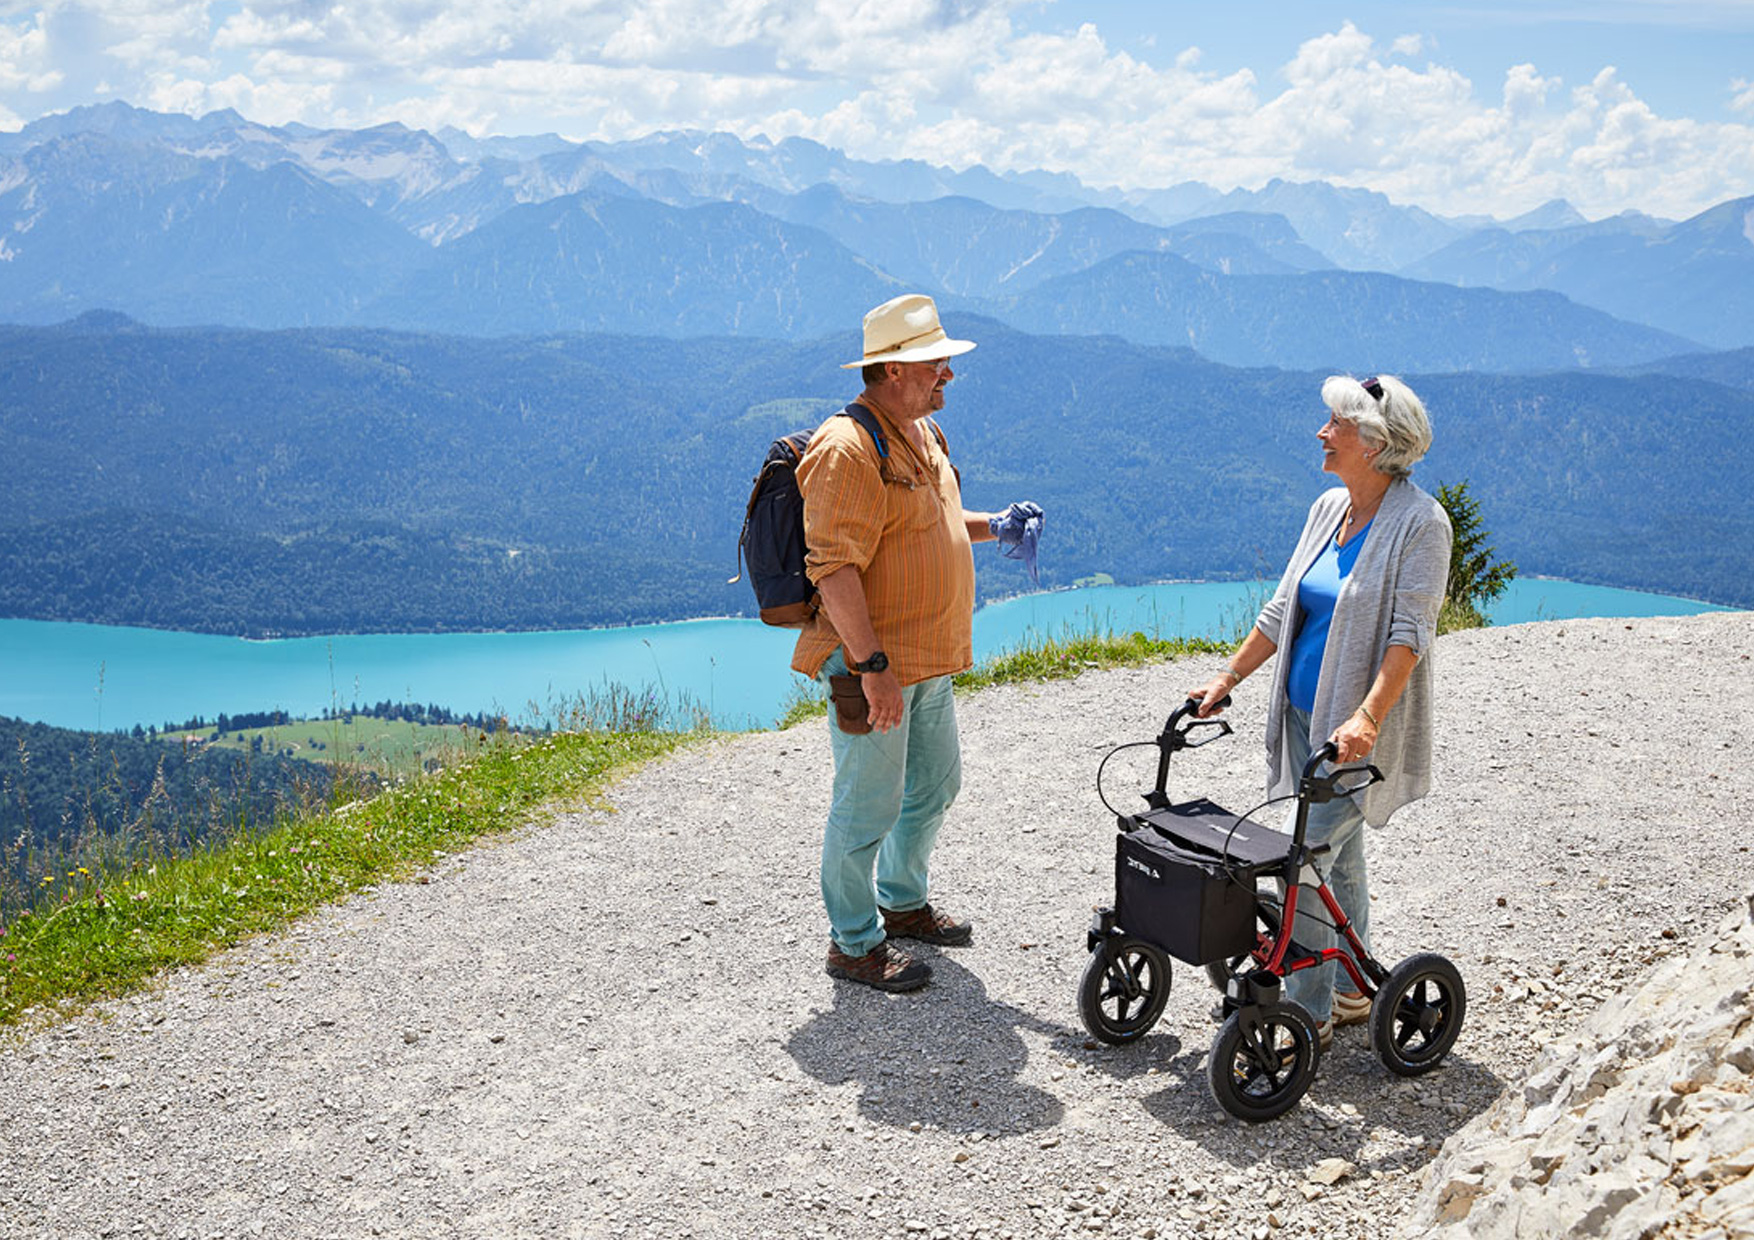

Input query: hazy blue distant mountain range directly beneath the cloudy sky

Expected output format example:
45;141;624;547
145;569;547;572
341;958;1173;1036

0;103;1754;359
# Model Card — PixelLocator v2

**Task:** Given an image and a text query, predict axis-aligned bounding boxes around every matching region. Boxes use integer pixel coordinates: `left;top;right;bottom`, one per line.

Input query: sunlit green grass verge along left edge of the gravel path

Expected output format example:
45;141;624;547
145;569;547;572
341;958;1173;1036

0;731;700;1024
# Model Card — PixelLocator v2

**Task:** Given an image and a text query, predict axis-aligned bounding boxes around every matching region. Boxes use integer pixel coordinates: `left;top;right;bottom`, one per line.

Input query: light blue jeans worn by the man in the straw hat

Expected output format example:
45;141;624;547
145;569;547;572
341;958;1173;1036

817;651;963;956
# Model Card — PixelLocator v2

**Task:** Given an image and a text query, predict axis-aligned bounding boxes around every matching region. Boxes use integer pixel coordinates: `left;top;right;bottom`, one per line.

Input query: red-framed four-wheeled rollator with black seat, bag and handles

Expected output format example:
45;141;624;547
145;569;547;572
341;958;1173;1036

1079;698;1466;1121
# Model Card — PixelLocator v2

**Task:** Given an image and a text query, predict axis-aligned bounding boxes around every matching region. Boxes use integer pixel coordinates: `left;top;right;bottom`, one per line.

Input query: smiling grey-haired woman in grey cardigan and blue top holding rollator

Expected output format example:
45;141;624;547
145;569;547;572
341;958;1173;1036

1189;375;1451;1047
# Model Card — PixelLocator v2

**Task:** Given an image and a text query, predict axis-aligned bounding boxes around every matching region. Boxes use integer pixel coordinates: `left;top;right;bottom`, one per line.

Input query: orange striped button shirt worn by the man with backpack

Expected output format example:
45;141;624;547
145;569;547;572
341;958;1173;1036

791;402;975;686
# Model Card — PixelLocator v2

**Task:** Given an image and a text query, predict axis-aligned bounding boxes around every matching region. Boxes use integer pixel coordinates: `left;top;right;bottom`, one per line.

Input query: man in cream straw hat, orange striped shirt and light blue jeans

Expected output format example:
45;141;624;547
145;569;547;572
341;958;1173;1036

791;293;1042;991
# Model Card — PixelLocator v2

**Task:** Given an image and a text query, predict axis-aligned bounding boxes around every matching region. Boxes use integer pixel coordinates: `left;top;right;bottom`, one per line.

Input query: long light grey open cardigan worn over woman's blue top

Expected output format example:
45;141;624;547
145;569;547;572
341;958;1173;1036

1254;479;1451;826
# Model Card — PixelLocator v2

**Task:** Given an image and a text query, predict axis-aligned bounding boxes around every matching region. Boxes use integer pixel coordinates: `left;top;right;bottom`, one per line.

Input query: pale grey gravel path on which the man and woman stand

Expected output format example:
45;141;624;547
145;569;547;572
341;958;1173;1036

0;614;1754;1240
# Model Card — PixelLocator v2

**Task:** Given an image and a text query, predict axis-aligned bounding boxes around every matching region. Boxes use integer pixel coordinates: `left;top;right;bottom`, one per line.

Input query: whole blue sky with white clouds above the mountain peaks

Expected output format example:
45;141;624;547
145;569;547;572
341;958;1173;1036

0;0;1754;217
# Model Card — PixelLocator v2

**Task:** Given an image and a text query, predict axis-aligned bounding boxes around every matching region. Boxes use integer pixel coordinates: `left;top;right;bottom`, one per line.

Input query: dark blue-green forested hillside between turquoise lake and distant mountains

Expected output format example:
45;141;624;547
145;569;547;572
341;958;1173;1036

0;316;1754;633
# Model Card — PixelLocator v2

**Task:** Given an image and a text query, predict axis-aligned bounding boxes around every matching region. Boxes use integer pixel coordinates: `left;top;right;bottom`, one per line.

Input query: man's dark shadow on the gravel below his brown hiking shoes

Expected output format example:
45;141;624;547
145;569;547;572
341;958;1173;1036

786;956;1075;1137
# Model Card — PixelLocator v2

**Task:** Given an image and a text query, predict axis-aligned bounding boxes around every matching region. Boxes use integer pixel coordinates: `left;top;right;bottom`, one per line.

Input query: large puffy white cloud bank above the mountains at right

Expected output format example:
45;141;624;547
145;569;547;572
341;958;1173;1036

770;23;1754;216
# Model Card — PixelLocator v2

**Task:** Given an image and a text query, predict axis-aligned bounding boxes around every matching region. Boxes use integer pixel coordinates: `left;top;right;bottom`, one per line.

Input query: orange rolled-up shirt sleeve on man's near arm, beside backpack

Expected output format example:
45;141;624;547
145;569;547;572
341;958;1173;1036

798;417;888;584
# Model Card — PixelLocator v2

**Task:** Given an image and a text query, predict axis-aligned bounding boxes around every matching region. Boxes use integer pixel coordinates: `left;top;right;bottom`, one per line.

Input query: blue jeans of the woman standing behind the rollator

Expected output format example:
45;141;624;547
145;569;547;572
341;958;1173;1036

1286;702;1370;1023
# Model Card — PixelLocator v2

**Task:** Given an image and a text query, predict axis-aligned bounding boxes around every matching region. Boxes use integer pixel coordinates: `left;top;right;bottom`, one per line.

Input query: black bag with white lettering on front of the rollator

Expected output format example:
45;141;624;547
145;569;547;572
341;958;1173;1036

1114;826;1254;965
